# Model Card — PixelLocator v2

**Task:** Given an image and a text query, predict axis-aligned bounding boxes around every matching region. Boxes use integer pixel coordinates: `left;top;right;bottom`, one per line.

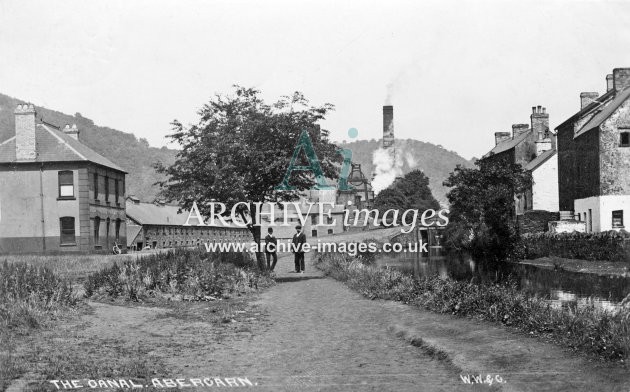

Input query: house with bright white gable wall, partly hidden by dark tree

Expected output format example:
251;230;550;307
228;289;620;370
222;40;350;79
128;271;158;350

481;106;559;215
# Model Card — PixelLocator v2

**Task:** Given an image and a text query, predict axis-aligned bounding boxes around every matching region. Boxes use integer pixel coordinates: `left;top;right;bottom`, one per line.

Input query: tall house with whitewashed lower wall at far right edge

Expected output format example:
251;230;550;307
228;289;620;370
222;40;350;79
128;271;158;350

556;68;630;232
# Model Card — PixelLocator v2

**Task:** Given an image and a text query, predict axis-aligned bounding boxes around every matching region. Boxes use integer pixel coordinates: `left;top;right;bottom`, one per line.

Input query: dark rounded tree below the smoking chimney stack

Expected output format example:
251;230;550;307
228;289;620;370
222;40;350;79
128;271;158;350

374;169;440;224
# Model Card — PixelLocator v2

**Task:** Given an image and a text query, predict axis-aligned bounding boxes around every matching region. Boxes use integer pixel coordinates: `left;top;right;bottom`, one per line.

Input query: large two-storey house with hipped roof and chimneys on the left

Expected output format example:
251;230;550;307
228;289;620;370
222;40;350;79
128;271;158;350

0;104;126;254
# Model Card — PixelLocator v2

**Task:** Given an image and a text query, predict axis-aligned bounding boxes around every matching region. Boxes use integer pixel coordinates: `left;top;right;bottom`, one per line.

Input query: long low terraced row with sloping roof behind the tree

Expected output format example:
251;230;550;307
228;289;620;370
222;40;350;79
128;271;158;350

126;196;252;250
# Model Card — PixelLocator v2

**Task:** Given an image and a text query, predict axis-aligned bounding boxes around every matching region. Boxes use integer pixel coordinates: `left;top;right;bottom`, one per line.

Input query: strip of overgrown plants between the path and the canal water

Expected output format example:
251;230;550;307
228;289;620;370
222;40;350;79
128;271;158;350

315;248;630;362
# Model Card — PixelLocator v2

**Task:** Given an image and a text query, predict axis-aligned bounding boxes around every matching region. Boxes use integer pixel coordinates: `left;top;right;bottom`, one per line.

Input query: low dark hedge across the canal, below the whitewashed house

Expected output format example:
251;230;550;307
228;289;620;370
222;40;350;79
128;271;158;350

513;231;630;261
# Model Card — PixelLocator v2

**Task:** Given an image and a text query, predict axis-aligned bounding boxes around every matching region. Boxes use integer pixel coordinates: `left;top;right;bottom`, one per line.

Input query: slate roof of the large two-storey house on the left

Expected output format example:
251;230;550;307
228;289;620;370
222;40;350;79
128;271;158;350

0;124;126;173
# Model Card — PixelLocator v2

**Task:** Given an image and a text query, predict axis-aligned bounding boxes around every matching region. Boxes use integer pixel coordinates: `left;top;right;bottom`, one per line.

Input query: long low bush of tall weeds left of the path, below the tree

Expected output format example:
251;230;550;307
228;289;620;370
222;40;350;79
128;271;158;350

84;250;272;301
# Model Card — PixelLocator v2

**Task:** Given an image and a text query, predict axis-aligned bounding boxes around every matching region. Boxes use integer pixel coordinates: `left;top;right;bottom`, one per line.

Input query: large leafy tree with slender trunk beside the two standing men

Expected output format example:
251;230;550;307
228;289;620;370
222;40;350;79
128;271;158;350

156;86;341;269
